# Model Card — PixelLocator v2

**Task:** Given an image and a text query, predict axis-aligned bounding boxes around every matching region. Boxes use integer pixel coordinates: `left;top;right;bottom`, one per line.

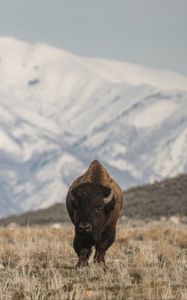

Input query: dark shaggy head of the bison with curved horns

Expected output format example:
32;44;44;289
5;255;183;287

71;183;115;248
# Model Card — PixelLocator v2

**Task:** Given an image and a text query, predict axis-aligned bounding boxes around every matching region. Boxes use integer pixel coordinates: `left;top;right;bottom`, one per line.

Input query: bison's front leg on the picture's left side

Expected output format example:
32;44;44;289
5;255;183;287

73;235;92;268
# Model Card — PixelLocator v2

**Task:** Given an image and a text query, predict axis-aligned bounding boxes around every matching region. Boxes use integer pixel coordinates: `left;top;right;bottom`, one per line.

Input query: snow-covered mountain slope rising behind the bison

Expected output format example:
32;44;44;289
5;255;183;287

0;37;187;217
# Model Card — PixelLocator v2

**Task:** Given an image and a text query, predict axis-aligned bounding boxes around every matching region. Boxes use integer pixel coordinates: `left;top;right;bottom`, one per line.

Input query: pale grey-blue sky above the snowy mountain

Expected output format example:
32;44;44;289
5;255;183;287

0;0;187;76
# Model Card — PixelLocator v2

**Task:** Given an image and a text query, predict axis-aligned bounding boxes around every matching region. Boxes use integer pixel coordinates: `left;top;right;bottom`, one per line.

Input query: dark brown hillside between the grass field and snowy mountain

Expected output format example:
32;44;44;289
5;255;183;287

0;175;187;225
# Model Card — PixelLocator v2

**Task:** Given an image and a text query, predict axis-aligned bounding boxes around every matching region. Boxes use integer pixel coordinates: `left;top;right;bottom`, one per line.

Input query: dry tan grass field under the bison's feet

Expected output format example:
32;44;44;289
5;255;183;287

0;221;187;300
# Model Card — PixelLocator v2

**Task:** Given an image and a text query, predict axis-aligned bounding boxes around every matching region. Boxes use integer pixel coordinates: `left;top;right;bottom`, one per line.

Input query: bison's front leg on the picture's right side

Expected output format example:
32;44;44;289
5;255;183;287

94;227;116;267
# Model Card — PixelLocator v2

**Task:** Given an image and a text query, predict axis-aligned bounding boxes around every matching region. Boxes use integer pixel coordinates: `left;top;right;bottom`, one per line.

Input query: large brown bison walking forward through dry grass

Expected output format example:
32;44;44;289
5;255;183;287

66;160;123;267
